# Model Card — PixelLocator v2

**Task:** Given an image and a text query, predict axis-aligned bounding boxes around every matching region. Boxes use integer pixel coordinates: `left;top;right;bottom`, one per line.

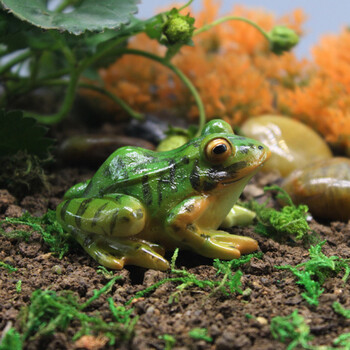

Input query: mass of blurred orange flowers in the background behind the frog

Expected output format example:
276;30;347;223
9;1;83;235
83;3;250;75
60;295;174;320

80;0;350;153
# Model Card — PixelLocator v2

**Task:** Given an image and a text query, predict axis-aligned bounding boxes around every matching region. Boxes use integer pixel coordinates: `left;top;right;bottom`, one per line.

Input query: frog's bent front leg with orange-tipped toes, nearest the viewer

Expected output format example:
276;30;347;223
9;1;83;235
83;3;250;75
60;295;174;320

167;196;258;260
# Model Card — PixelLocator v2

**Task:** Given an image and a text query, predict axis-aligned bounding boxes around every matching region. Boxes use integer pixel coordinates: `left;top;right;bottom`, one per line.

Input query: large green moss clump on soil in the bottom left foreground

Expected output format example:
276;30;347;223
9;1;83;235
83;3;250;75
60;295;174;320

21;276;137;345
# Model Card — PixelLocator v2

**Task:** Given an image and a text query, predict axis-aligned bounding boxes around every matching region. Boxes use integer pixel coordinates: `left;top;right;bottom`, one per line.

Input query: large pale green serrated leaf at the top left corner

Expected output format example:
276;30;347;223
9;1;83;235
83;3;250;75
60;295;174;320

0;0;139;35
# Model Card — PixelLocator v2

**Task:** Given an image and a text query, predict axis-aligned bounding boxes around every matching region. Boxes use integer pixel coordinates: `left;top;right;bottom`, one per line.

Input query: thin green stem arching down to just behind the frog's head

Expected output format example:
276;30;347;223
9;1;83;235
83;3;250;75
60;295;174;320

121;49;206;136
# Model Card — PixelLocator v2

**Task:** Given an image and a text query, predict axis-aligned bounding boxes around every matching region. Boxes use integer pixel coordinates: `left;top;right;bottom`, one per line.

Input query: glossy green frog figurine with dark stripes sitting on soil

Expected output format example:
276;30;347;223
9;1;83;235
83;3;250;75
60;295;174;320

57;120;270;270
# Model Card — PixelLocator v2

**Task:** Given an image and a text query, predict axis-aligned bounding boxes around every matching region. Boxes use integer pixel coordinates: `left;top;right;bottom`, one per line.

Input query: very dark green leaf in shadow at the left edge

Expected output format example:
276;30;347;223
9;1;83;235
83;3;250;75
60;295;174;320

0;110;54;157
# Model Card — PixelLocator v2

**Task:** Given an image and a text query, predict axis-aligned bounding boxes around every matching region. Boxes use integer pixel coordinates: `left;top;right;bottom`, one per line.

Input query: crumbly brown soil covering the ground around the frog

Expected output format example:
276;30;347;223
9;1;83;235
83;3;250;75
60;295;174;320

0;138;350;350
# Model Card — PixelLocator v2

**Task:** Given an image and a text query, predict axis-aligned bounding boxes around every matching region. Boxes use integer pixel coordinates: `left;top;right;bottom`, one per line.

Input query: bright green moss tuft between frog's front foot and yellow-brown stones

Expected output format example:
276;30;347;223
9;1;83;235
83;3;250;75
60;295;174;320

247;186;310;239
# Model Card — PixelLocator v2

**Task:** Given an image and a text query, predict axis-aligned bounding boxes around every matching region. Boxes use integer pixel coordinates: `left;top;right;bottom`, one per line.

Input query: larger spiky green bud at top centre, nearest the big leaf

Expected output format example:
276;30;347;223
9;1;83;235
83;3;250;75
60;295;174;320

162;9;194;45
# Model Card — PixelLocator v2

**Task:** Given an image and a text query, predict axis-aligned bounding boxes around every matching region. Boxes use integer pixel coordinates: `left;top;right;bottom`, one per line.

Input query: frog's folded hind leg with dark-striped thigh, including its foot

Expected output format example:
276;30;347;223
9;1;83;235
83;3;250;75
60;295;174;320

57;194;169;270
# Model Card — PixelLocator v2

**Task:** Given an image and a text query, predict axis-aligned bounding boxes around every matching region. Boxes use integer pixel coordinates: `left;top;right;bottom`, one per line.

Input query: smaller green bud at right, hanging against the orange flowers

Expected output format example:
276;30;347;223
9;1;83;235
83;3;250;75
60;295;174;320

268;26;299;55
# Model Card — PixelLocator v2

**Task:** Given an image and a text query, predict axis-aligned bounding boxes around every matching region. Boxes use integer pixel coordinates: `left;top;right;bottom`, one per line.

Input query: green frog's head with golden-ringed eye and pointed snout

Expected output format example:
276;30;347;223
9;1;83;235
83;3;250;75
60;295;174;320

190;119;271;191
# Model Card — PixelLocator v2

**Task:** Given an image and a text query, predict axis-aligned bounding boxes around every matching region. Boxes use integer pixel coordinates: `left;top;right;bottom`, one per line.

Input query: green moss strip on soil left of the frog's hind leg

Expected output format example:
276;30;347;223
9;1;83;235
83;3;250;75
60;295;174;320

0;210;74;259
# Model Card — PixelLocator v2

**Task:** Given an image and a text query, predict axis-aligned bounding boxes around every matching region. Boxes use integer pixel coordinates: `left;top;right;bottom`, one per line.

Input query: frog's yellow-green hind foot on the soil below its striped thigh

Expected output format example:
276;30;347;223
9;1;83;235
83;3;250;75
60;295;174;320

73;231;169;271
